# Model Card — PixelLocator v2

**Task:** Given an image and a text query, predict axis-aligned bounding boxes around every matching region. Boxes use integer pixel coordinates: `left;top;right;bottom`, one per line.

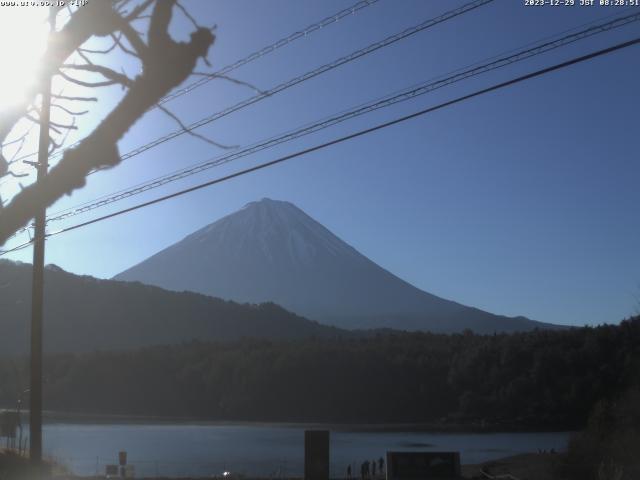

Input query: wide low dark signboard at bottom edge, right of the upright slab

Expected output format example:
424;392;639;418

387;452;461;480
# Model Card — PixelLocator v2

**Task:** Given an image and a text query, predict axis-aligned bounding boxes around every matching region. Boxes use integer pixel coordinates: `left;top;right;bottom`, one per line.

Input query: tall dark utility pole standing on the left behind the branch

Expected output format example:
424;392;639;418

29;7;56;477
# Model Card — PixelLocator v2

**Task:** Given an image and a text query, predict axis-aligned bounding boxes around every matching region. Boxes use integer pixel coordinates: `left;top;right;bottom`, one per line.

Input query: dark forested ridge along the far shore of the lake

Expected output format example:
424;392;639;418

0;318;640;428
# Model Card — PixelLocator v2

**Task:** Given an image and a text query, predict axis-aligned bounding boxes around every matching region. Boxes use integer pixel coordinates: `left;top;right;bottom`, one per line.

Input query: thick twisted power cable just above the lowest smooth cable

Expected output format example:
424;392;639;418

43;13;640;222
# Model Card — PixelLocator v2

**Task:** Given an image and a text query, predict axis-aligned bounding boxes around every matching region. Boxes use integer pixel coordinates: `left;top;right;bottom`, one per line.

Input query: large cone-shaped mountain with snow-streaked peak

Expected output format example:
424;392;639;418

115;199;545;332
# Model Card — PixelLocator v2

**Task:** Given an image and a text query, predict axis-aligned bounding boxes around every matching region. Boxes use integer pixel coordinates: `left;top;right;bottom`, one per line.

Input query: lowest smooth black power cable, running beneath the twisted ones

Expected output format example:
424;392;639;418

6;33;640;251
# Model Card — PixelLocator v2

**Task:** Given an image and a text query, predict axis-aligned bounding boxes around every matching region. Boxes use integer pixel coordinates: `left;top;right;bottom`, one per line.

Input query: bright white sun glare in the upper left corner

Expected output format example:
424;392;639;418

0;7;48;112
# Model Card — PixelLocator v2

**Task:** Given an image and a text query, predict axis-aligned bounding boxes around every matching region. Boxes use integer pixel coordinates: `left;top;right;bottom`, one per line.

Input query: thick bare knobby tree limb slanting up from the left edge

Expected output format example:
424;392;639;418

0;0;215;245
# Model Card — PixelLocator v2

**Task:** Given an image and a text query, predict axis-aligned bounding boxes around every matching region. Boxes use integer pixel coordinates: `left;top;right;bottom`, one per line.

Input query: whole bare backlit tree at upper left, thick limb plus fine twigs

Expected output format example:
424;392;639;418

0;0;215;245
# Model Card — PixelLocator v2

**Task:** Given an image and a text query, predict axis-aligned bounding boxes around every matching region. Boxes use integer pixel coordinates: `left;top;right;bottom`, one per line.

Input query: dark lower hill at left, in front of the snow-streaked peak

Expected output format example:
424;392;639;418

0;260;341;354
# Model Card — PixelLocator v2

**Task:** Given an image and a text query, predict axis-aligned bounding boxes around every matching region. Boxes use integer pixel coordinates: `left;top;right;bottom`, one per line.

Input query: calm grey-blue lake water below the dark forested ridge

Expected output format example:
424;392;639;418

43;424;569;478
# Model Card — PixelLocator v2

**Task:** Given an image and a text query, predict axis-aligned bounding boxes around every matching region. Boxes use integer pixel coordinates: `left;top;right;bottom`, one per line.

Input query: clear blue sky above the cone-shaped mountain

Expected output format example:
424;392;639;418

1;0;640;325
